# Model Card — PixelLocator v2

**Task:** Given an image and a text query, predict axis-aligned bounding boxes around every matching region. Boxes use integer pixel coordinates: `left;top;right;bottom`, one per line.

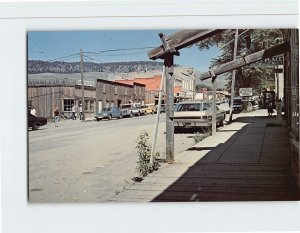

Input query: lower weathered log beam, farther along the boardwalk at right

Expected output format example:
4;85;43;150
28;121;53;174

200;42;289;80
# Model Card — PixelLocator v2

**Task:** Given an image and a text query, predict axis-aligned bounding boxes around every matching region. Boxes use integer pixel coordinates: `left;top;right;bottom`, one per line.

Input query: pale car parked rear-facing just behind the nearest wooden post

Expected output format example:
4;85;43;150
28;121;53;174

174;101;226;129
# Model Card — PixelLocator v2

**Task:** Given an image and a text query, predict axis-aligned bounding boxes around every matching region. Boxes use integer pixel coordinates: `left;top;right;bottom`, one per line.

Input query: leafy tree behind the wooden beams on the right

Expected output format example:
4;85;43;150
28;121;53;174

197;29;283;94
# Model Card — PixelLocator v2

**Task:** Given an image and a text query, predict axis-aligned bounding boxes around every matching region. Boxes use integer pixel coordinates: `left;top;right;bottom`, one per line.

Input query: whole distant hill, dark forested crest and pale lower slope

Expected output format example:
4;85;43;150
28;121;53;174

28;60;228;88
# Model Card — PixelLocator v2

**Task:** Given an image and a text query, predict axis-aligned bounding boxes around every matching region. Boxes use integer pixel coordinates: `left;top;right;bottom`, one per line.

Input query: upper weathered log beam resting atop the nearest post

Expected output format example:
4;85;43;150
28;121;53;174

148;29;225;60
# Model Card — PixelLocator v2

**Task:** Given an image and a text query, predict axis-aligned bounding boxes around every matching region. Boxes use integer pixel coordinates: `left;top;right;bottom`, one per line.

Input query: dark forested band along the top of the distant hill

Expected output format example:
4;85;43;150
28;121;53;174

27;60;163;74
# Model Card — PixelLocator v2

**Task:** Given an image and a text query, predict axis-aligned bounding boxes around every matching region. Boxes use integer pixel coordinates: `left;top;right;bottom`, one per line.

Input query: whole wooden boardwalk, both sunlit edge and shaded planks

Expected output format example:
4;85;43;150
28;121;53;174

110;110;299;202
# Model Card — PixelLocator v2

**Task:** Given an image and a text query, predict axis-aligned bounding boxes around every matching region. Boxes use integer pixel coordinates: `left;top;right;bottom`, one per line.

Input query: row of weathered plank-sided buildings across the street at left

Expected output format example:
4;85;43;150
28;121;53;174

27;76;145;118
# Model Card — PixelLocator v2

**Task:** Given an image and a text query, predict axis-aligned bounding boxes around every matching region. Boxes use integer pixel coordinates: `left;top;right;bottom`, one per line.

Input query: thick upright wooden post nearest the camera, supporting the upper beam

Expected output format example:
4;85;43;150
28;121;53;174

165;54;174;163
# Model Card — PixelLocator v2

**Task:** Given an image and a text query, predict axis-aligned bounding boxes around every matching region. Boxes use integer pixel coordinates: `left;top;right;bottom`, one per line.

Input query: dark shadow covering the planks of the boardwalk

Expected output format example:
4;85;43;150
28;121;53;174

152;117;299;202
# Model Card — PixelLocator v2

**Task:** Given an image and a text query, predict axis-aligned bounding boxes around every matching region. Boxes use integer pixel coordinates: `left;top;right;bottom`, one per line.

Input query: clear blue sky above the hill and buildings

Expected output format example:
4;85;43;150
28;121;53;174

28;30;220;71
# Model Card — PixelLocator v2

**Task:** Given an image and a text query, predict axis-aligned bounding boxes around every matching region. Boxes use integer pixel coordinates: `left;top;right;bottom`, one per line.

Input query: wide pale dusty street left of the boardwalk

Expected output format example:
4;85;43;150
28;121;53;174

28;114;194;202
